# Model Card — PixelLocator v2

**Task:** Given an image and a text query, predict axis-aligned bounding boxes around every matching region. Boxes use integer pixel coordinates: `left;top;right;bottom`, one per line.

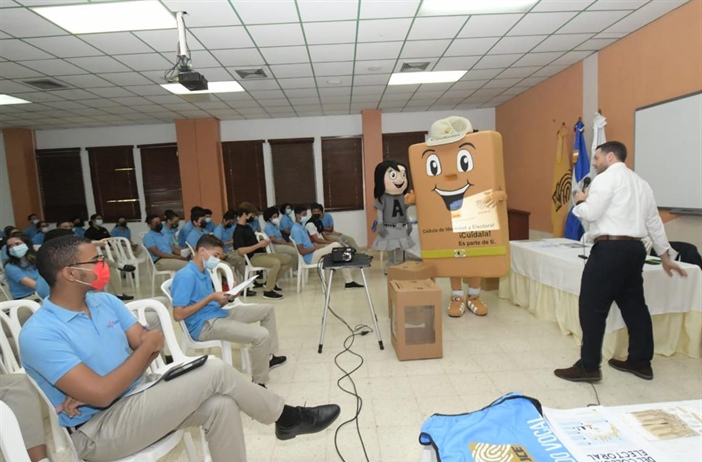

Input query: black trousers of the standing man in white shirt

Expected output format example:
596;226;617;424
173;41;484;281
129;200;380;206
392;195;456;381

579;241;653;370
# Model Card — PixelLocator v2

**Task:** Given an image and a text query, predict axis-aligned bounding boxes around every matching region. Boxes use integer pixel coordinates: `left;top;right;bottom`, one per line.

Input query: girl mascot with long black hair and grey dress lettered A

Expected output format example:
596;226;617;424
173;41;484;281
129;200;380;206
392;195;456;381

373;160;414;266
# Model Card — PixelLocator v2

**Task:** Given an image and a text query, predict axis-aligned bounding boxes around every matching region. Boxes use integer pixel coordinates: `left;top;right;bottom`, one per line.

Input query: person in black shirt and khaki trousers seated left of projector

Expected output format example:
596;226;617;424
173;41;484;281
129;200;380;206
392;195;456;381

234;202;292;300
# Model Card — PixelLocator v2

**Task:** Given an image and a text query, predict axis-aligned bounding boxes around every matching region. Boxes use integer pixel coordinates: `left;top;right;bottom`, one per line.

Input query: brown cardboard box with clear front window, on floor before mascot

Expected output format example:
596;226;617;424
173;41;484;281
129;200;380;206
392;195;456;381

390;279;444;361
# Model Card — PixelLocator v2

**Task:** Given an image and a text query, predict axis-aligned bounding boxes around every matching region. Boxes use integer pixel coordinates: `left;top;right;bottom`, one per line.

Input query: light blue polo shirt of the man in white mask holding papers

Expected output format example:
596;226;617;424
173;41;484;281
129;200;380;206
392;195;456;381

171;262;228;339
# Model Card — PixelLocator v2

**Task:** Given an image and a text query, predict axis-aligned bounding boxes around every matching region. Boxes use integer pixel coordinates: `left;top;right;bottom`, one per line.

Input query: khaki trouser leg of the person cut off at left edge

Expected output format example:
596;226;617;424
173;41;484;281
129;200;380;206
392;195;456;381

0;374;46;449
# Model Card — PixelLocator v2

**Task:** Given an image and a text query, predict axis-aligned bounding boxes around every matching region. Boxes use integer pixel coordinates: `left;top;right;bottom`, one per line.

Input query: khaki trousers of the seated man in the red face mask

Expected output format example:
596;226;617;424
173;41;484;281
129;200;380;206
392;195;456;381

71;357;284;462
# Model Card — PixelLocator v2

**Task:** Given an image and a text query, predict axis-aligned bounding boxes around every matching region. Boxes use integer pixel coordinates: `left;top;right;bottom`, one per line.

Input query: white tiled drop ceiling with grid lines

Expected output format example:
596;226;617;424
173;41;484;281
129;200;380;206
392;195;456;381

0;0;687;129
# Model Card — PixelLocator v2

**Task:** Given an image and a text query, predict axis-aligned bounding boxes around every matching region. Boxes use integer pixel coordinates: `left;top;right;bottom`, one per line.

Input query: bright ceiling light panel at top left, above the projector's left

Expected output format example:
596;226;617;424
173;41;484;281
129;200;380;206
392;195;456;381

32;0;177;34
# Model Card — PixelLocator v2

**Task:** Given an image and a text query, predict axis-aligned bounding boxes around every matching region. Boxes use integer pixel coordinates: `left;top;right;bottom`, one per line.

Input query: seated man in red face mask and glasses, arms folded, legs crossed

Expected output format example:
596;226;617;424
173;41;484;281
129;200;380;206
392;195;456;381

20;236;340;462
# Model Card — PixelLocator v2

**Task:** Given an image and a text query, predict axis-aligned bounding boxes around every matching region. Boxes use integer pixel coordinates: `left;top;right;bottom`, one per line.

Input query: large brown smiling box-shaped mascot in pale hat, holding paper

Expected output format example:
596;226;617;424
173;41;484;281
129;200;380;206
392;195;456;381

407;117;510;317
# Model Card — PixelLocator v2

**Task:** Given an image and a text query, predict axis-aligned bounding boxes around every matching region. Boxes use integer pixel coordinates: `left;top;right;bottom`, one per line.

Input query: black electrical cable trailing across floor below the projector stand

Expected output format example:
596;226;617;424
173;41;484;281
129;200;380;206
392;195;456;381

317;260;373;462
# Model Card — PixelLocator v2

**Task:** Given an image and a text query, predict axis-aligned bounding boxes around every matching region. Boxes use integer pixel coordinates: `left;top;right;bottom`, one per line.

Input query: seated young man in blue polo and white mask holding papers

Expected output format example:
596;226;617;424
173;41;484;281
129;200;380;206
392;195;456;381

171;235;287;386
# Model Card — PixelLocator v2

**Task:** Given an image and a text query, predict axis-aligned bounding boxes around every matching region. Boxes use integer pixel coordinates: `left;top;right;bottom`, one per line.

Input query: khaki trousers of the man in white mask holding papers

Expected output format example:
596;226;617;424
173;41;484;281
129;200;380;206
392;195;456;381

198;303;278;383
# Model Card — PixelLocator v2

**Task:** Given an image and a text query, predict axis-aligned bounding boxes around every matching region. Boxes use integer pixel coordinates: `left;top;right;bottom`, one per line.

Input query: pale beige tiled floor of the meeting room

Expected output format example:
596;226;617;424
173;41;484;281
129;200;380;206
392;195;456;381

51;262;702;462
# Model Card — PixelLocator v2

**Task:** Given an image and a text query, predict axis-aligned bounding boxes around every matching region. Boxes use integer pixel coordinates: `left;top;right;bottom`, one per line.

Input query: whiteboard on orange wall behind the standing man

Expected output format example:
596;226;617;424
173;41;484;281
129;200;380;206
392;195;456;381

634;93;702;211
